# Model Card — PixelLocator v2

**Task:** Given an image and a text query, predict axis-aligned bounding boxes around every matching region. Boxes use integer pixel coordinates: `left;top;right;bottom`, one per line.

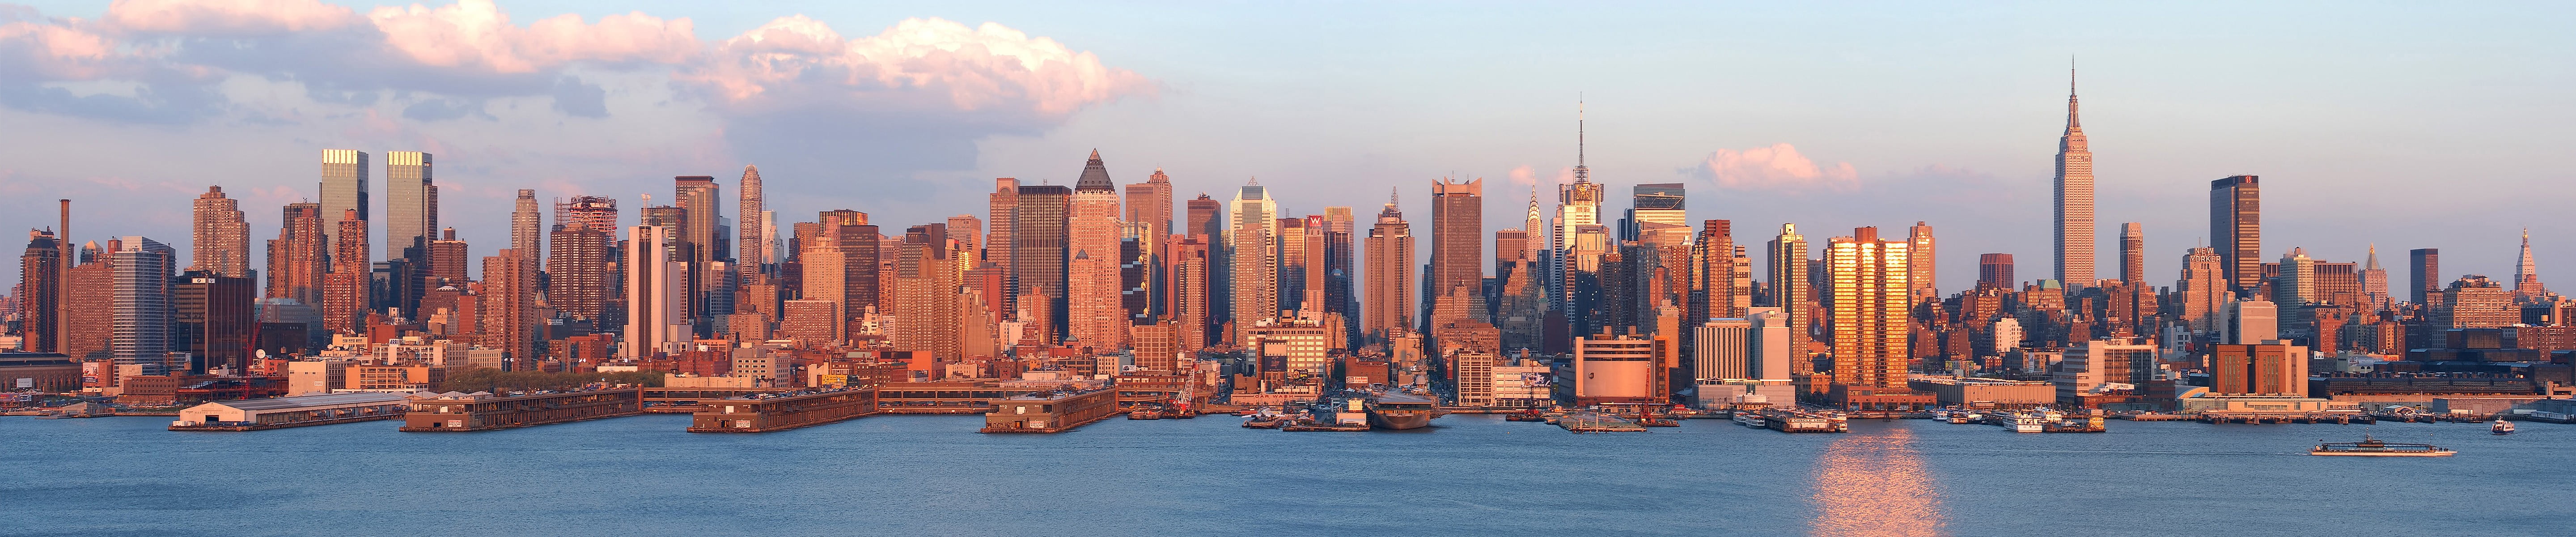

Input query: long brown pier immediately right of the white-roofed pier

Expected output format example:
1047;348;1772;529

402;387;644;431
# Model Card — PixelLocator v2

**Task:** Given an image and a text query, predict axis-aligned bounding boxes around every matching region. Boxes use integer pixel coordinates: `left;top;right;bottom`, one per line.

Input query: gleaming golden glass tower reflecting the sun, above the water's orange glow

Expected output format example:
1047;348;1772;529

1826;227;1911;390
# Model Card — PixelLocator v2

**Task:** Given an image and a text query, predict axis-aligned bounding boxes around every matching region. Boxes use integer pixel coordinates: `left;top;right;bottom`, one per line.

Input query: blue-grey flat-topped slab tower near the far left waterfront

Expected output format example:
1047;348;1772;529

108;238;186;375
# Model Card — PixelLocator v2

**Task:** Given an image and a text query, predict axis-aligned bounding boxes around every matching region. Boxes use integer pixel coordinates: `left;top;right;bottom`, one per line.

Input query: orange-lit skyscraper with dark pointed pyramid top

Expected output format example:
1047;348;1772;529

1064;150;1128;349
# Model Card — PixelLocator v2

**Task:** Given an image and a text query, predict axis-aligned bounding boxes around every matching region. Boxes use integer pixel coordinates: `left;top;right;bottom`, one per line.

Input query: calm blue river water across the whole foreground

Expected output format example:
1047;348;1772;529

0;416;2576;537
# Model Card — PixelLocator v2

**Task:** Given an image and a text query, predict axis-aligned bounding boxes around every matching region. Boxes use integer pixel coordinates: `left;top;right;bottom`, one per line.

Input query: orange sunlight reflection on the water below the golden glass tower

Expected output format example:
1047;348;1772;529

1811;429;1942;537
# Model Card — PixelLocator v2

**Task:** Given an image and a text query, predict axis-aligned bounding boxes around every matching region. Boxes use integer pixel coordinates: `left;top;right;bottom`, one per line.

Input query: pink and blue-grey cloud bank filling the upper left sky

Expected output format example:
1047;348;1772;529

0;0;1157;170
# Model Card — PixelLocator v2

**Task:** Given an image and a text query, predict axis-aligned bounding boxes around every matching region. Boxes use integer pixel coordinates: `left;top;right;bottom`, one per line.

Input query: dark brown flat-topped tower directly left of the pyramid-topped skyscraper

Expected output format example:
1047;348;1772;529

1010;186;1074;343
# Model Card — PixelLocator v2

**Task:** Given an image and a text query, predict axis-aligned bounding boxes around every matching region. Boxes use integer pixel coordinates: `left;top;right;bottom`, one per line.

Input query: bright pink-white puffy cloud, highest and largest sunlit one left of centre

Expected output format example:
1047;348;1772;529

680;16;1154;116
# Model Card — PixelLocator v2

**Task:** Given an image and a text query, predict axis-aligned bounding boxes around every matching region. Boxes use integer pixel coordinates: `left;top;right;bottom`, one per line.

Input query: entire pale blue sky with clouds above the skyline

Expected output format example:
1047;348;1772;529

0;0;2576;292
